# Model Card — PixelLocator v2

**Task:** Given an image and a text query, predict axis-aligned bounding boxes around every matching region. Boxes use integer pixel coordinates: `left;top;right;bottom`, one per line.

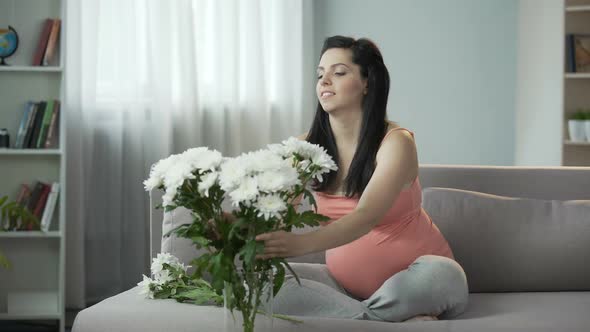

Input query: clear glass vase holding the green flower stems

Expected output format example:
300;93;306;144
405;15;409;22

223;269;274;332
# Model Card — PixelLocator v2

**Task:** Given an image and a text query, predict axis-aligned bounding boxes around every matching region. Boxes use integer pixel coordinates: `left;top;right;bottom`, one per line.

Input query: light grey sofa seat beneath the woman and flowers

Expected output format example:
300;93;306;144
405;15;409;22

72;287;590;332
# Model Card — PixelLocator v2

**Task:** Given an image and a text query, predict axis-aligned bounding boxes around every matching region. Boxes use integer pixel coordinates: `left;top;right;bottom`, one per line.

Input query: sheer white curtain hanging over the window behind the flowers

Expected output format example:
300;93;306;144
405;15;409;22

64;0;315;308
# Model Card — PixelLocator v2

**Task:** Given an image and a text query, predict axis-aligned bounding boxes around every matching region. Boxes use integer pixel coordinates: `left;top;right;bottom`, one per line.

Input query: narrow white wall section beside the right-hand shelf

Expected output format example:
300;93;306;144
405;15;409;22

515;0;565;166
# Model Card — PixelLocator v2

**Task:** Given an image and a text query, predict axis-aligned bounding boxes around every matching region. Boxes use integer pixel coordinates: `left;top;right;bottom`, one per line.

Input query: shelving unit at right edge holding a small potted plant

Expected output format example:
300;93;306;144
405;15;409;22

561;0;590;166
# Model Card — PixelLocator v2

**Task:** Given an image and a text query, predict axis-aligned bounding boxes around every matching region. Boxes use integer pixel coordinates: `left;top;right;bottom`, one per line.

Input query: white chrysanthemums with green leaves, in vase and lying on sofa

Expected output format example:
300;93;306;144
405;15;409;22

140;137;337;328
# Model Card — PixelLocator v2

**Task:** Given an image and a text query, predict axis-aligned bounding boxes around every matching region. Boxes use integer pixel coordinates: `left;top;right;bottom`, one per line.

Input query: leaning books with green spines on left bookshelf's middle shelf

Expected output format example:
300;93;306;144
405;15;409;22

14;100;60;149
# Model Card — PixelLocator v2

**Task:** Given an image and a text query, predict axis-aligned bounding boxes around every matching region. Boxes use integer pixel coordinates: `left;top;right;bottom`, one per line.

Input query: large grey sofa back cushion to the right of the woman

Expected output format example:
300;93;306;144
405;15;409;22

423;188;590;292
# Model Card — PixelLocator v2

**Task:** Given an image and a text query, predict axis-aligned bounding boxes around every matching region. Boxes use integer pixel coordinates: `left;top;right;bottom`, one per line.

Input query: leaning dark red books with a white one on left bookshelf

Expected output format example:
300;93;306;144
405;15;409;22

14;181;59;232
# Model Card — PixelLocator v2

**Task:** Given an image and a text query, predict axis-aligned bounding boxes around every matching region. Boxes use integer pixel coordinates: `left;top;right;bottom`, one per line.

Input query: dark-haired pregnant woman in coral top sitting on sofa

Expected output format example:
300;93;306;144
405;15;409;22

256;36;468;322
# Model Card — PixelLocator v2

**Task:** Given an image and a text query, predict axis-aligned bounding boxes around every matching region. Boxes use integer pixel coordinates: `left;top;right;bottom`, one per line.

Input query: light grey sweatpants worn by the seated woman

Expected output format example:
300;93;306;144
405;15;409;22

273;255;469;322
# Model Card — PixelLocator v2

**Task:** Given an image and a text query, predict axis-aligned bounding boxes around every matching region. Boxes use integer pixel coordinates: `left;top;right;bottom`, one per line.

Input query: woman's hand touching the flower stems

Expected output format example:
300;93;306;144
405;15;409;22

256;231;311;259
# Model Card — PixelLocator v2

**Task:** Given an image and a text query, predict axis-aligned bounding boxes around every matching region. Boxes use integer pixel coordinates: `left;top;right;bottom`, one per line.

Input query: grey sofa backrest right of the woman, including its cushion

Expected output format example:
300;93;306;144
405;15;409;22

420;165;590;292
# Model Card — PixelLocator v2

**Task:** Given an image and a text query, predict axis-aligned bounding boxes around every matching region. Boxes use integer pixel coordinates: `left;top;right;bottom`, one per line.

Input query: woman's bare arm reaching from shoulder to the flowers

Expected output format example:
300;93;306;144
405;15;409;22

256;131;418;259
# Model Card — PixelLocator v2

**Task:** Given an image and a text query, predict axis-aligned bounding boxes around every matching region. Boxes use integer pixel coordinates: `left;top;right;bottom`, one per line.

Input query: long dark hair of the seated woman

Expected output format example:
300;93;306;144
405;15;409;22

306;36;389;197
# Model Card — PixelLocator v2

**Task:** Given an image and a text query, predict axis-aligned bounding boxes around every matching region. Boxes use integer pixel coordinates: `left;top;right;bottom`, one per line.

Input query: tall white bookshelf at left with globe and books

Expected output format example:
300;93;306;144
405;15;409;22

0;0;66;332
